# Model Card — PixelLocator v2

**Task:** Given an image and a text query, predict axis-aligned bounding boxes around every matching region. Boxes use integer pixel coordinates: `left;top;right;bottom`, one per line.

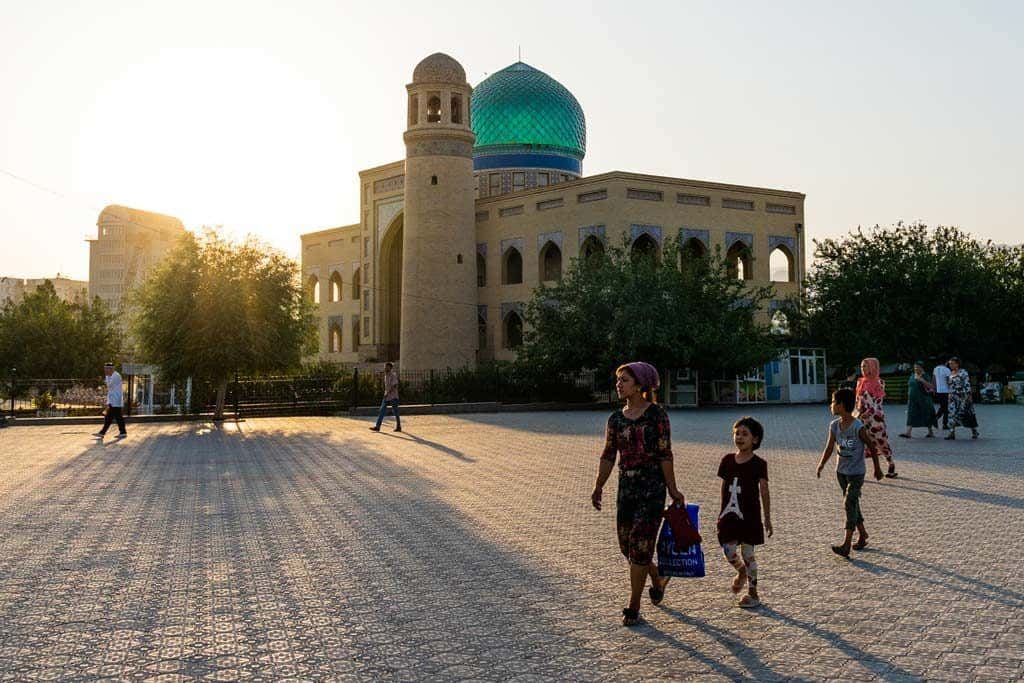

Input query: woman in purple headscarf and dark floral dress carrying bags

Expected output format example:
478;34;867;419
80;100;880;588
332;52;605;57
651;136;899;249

590;361;686;626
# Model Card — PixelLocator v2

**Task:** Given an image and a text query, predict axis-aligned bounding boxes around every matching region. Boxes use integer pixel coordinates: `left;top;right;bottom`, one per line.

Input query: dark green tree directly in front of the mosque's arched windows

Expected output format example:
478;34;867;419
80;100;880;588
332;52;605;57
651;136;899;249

519;240;777;373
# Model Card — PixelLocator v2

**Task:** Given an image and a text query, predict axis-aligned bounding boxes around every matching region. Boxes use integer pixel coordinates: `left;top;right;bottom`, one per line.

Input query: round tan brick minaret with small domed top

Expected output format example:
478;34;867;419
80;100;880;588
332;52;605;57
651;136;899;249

399;52;477;372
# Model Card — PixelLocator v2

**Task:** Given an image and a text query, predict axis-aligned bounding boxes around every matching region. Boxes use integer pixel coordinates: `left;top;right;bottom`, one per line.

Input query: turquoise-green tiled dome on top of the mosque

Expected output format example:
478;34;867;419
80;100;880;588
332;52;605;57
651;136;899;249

470;61;587;160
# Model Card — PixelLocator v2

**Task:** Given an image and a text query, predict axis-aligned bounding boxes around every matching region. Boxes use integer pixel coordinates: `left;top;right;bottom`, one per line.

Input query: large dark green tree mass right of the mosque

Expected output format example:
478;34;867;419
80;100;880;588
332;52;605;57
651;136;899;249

800;223;1024;374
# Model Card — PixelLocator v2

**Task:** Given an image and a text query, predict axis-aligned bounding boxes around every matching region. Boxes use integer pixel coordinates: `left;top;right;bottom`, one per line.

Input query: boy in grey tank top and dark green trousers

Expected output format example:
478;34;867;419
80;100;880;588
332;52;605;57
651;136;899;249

817;389;883;557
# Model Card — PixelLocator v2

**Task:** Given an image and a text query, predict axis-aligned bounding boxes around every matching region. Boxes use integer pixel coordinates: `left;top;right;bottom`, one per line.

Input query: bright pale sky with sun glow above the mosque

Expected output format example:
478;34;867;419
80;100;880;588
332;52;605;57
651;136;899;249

0;0;1024;280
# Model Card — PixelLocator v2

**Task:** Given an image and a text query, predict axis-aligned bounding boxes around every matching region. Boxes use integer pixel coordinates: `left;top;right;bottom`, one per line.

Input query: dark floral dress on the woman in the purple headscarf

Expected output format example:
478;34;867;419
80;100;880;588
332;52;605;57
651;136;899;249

601;403;672;565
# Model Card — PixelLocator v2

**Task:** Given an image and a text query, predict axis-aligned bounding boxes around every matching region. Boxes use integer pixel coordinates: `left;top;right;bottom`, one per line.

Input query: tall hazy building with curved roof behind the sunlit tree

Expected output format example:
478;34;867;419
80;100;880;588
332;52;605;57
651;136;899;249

88;204;185;310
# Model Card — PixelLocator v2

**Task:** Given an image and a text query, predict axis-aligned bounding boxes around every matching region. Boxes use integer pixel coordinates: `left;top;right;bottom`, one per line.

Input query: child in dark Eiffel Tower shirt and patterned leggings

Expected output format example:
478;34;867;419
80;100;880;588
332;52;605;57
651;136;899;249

718;417;774;608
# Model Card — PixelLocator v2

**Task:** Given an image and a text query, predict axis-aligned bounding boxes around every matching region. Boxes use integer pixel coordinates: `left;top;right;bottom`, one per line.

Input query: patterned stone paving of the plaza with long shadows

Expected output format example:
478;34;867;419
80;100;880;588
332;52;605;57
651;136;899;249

0;407;1024;681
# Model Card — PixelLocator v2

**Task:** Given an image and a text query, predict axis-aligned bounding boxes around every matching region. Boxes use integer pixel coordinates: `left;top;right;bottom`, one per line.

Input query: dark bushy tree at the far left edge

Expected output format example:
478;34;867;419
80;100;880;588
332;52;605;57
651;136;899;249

0;281;122;379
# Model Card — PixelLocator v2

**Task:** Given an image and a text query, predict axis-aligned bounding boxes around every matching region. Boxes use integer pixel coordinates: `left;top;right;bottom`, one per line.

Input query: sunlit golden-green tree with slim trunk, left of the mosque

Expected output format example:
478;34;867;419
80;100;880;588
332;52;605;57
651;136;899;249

132;229;316;419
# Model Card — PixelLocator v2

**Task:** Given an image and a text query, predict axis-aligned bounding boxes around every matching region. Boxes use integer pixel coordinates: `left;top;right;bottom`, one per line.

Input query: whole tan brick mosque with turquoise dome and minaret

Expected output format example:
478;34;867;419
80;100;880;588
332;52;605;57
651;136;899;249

301;53;804;372
